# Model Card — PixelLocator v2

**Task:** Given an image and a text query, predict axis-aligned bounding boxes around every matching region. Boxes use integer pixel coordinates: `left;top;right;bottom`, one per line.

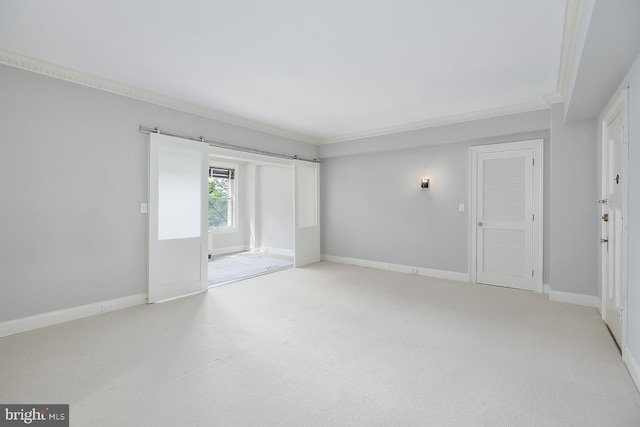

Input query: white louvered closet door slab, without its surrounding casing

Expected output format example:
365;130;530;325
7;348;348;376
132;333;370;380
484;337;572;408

476;149;535;290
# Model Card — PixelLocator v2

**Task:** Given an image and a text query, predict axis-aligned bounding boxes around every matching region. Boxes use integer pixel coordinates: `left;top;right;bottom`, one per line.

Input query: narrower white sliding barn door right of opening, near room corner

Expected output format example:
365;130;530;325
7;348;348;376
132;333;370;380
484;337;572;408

293;160;320;267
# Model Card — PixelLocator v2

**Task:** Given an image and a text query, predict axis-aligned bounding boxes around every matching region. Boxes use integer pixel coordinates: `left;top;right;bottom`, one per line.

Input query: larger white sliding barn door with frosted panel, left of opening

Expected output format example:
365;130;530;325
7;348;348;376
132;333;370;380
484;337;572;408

148;133;209;303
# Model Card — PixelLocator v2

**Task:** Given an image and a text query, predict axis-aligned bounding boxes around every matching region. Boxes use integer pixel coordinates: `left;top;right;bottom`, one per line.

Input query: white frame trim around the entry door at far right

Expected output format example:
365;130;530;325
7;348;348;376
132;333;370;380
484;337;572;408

599;87;629;349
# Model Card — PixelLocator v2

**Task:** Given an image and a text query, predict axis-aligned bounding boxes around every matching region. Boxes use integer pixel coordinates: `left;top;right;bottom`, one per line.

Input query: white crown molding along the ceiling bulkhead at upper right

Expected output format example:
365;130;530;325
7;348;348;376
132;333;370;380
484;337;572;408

557;0;584;99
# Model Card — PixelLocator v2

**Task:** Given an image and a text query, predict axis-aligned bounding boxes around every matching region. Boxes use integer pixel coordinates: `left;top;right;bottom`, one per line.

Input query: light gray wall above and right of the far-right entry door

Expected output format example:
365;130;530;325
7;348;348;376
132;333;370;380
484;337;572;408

598;56;640;362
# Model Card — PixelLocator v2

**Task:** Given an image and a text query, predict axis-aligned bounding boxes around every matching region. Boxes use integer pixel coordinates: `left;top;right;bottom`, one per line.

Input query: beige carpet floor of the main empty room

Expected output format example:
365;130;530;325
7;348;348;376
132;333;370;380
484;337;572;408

0;263;640;426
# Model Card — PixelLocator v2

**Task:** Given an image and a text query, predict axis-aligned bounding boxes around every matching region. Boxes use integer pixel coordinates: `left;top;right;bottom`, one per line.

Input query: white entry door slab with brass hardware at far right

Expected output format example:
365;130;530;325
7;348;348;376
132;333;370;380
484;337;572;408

603;104;626;347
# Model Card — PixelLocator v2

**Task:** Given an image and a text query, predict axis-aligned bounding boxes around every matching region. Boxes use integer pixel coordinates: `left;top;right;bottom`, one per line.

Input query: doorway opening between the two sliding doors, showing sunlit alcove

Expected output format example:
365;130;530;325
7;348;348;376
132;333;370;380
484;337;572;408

207;148;294;287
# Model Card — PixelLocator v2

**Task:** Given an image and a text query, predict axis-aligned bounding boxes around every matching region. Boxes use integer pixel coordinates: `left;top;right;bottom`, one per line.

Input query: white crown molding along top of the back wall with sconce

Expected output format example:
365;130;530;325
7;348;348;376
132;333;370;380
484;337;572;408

319;93;563;145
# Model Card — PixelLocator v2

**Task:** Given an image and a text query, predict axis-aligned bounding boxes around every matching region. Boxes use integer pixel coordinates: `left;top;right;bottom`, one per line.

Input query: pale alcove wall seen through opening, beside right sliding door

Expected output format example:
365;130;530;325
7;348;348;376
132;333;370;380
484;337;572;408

256;166;293;251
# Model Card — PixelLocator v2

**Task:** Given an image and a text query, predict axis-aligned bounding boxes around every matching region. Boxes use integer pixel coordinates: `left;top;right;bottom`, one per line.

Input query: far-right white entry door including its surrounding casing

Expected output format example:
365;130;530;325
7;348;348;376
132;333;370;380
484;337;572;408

601;90;628;349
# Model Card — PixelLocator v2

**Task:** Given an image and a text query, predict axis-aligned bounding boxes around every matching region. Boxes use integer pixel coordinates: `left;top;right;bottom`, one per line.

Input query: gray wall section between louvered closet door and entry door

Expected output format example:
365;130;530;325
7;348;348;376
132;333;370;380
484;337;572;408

550;104;599;295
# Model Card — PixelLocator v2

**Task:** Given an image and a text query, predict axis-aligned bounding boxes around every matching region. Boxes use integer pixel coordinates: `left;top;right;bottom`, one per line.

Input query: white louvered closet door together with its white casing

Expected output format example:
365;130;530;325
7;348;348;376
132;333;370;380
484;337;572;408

470;140;543;292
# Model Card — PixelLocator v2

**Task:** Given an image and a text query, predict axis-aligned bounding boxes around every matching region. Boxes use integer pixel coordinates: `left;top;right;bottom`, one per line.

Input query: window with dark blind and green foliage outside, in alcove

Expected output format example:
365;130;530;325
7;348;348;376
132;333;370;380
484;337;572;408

209;166;235;230
